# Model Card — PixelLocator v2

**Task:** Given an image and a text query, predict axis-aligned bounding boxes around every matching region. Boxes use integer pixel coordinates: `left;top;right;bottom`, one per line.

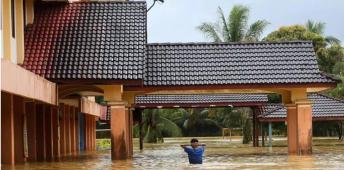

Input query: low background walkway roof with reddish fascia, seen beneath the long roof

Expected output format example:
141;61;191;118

135;93;268;107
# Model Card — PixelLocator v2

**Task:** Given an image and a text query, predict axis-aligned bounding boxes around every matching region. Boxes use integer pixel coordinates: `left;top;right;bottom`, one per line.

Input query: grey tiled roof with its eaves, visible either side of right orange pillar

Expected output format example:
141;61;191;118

259;93;344;121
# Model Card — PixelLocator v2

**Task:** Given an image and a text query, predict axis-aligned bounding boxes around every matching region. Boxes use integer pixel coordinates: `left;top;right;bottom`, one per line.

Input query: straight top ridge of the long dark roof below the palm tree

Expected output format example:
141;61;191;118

147;40;312;46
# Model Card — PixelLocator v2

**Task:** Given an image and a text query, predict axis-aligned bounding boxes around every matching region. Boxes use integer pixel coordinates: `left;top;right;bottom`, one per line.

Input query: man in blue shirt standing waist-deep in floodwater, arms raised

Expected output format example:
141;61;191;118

180;138;205;164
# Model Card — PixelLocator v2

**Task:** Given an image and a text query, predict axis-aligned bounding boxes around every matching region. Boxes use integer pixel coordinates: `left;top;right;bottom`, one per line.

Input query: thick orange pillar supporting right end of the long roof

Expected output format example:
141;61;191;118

286;101;312;155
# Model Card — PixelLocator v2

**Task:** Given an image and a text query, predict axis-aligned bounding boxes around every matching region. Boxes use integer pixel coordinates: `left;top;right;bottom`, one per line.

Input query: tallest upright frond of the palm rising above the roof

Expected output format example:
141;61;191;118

228;5;249;42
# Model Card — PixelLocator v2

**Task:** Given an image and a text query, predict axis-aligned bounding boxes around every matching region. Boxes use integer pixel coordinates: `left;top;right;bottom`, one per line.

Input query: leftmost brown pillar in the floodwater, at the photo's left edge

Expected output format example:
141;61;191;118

1;92;15;165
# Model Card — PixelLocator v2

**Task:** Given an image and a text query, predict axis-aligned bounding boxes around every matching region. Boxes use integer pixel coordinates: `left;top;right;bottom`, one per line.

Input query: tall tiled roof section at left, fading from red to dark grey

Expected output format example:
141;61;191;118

23;1;147;80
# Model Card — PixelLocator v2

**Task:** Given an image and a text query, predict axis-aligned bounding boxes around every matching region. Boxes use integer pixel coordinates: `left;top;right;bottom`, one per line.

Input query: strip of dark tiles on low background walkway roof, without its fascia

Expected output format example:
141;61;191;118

135;93;268;104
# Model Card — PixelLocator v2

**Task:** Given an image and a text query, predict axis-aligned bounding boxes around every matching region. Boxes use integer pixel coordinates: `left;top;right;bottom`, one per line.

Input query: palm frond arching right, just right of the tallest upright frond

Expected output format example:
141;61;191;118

244;20;270;42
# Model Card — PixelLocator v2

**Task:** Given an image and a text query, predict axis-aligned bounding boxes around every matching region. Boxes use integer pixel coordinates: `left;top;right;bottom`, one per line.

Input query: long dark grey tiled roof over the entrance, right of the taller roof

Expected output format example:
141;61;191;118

144;41;334;86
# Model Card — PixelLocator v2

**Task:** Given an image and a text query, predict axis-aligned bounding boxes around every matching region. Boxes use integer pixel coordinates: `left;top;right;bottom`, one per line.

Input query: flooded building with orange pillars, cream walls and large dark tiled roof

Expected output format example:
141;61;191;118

1;0;337;164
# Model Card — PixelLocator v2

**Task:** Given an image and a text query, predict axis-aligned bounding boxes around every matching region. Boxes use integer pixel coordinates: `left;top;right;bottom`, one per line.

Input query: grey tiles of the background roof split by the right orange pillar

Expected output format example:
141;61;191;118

260;93;344;119
